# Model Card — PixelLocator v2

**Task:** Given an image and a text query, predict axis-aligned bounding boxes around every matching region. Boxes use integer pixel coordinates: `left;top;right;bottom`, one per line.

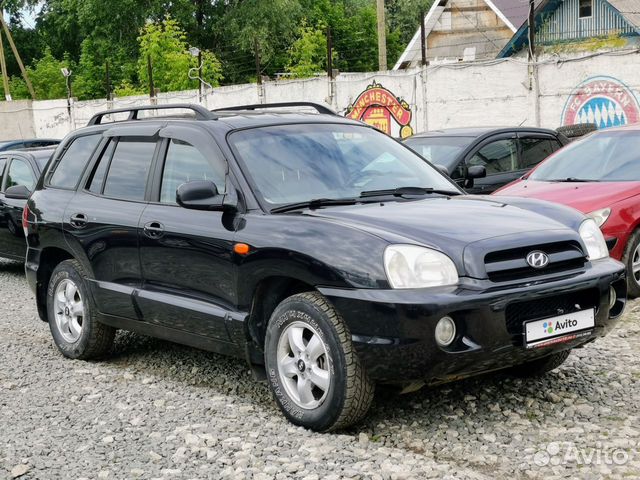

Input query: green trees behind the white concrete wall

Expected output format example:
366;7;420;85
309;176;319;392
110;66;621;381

0;0;424;100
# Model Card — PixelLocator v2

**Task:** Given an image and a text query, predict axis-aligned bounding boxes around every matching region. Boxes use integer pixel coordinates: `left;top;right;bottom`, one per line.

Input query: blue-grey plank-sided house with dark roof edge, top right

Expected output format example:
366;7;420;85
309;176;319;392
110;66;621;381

498;0;640;58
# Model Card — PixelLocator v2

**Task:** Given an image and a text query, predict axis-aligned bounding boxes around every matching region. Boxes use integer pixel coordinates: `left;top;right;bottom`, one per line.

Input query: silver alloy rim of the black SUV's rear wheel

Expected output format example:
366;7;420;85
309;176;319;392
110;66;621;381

53;279;84;343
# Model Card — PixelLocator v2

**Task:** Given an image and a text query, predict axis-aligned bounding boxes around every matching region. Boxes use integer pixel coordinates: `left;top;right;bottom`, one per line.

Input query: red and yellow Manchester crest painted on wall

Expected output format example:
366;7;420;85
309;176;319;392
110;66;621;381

346;82;413;138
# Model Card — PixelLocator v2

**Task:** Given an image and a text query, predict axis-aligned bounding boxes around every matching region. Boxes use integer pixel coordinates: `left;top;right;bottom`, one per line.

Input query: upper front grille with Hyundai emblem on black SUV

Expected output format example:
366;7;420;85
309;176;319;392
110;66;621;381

484;241;587;282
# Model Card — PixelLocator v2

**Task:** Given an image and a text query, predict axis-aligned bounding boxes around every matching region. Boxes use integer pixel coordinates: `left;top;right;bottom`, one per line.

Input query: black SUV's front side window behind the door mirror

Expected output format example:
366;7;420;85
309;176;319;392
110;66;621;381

160;140;224;203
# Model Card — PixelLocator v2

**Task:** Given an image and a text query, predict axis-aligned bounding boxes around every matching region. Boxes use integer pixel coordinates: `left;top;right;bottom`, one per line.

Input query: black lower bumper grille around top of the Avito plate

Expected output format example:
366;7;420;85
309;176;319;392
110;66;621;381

505;289;600;335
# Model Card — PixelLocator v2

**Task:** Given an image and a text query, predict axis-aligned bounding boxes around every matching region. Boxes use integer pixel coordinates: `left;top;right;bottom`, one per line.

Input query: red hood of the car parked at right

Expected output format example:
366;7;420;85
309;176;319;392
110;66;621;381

496;180;640;213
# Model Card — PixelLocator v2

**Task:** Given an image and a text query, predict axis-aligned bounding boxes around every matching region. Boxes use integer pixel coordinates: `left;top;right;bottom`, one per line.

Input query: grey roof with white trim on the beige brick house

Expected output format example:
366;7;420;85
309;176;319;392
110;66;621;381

393;0;540;70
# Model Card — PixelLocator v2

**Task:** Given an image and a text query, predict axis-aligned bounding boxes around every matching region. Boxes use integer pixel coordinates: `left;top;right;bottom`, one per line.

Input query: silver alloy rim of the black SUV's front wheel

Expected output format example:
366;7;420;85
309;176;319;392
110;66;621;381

277;322;332;410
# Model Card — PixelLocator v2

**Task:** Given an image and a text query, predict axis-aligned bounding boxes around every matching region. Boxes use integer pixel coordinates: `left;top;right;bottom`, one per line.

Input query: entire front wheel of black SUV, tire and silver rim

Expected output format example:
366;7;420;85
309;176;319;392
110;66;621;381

265;292;374;432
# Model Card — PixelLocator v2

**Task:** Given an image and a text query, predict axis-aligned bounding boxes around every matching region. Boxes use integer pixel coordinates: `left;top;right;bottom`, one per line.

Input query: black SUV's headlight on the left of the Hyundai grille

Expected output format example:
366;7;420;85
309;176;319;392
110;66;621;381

384;245;458;288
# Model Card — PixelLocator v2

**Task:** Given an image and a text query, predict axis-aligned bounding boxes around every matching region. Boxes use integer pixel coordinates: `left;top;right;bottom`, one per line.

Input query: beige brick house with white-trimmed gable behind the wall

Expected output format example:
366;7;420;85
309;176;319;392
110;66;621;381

394;0;540;70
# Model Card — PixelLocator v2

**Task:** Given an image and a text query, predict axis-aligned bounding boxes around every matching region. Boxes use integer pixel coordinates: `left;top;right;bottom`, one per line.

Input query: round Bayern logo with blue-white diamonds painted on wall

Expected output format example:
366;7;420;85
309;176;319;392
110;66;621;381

562;76;640;129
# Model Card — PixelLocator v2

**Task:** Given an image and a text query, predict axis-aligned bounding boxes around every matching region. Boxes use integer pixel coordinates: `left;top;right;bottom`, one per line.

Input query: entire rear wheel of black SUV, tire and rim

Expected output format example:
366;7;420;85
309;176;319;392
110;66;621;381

47;260;116;360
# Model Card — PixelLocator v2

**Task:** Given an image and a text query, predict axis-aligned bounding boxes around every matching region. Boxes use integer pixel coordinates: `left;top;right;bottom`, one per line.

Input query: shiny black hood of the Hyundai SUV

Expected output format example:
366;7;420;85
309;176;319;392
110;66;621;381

306;195;581;276
